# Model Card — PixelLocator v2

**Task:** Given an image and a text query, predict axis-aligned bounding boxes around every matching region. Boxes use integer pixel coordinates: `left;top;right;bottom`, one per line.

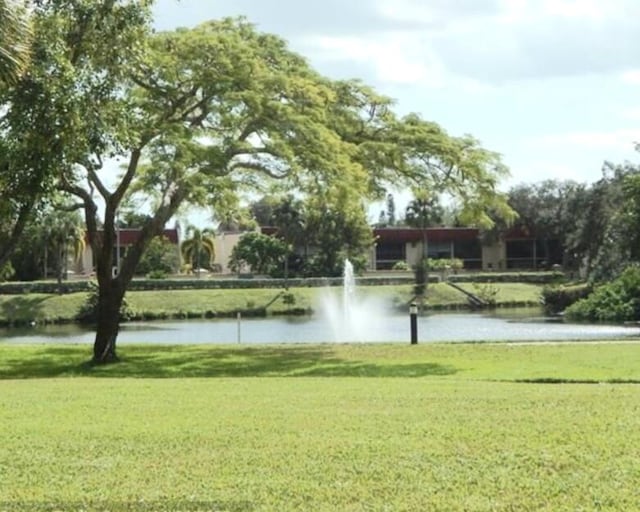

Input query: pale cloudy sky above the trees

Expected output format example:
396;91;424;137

155;0;640;192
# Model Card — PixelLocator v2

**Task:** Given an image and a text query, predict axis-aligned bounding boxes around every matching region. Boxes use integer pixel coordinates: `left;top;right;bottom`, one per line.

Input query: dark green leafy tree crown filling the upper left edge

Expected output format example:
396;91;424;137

0;0;149;272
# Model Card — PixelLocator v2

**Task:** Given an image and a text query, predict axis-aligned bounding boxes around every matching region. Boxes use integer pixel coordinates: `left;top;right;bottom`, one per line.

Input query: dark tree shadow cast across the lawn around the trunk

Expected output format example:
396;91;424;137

0;345;457;379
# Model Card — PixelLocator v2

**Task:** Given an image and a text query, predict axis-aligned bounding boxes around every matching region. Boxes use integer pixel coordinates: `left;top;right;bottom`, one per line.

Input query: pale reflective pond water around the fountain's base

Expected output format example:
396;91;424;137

0;310;640;344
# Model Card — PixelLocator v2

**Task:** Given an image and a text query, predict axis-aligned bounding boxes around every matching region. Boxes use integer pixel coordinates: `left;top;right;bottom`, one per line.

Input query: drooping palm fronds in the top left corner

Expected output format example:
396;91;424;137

0;0;32;83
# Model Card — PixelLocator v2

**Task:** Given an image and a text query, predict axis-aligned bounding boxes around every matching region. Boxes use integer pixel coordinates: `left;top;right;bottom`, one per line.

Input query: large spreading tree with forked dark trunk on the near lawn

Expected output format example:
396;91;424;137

2;11;510;363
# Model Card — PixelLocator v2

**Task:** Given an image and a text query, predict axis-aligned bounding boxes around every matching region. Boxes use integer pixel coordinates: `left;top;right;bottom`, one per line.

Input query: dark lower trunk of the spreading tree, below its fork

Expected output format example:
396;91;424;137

93;283;124;364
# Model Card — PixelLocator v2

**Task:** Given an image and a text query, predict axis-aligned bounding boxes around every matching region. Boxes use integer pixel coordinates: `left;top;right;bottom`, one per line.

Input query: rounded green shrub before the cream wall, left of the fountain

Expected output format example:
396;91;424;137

229;231;288;274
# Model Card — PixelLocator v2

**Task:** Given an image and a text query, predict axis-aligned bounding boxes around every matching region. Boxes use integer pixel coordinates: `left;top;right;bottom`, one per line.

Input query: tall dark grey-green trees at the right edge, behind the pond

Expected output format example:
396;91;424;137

504;169;640;281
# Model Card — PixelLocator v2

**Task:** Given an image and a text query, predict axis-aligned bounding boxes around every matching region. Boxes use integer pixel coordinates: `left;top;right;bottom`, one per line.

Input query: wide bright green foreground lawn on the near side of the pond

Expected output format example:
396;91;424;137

0;341;640;511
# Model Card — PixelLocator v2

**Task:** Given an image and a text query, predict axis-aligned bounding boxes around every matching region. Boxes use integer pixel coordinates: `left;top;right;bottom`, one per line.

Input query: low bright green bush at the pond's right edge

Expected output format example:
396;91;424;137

565;266;640;322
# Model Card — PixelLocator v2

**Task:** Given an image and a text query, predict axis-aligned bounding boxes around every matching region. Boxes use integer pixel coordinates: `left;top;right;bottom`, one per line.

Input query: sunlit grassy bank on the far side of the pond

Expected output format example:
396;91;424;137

0;283;542;325
